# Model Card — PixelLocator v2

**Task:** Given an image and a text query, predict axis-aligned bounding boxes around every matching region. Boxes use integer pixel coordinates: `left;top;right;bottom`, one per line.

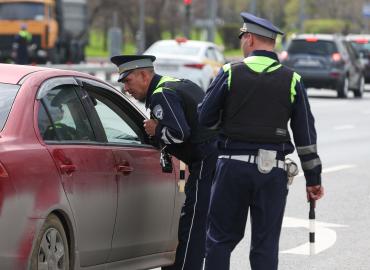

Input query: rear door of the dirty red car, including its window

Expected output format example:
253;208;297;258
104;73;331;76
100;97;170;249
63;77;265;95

38;77;117;266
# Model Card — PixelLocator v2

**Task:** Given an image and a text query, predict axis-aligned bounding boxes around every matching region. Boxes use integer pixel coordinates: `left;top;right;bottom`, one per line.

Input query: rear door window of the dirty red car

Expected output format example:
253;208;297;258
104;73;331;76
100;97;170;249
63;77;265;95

38;85;95;141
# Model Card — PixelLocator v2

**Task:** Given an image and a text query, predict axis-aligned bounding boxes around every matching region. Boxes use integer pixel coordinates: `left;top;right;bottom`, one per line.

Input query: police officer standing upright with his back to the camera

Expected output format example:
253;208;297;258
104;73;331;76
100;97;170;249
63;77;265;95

199;13;323;270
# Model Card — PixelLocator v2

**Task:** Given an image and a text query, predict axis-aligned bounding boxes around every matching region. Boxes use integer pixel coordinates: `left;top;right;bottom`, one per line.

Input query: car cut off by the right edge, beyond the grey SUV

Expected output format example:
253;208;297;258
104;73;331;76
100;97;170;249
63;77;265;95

346;34;370;83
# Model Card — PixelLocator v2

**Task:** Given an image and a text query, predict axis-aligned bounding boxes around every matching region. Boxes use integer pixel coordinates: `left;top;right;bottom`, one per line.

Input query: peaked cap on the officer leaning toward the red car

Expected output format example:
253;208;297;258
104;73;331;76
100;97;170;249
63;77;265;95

110;55;155;82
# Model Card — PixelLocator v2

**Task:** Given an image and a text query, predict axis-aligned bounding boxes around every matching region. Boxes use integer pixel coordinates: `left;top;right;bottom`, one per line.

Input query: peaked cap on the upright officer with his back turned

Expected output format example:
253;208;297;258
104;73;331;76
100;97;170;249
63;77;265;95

239;12;284;39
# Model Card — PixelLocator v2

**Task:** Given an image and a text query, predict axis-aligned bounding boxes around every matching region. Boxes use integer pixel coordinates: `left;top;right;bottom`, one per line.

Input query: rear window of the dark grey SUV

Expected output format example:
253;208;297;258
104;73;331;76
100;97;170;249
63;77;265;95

288;40;338;55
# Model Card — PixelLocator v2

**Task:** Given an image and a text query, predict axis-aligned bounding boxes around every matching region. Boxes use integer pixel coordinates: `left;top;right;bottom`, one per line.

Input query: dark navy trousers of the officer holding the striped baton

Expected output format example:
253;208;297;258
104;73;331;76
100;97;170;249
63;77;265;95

205;158;288;270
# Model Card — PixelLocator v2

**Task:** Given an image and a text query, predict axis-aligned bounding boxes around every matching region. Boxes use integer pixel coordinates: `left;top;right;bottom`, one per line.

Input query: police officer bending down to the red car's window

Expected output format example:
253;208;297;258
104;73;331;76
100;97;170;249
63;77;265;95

111;55;218;270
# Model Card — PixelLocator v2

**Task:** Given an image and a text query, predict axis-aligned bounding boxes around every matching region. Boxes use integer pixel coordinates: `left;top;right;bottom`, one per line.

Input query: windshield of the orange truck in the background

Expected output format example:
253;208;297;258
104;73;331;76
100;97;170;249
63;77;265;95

0;2;45;20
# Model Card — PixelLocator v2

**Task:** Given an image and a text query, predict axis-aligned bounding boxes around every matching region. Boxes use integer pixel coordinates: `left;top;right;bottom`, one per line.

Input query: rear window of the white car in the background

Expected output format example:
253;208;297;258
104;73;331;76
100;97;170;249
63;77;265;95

146;43;200;56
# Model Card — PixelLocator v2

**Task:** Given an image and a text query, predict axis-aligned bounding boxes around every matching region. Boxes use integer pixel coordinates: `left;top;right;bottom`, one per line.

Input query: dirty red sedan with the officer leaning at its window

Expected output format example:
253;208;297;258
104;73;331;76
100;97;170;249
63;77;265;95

0;64;184;270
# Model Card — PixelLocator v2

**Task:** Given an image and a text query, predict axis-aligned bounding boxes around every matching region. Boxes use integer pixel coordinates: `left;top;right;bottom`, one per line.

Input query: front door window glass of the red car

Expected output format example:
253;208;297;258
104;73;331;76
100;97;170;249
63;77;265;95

95;97;142;144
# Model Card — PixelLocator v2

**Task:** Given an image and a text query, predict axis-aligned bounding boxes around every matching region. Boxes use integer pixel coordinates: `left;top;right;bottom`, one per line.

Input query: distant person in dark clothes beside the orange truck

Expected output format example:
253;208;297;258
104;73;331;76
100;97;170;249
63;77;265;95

13;24;32;65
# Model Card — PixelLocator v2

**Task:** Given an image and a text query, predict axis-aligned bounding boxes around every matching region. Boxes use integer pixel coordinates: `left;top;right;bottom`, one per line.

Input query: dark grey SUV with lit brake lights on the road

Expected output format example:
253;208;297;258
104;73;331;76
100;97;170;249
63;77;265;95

280;34;365;98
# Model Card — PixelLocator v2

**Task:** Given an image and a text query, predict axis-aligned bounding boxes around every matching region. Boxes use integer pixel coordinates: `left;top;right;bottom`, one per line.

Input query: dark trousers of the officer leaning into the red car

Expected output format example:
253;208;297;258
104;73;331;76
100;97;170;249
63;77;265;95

162;141;218;270
